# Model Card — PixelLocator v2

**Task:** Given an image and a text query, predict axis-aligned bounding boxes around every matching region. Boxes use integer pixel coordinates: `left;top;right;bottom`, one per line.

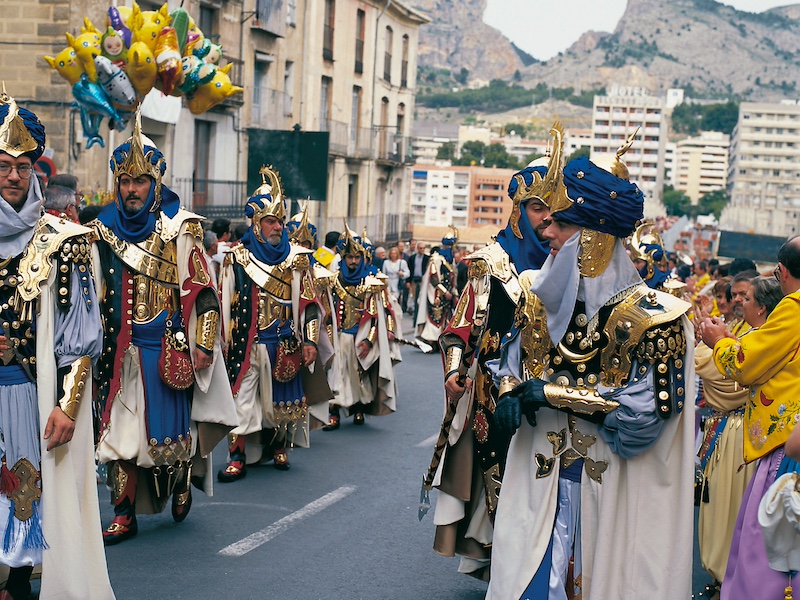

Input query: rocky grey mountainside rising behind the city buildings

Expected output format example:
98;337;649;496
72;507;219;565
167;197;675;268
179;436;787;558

410;0;800;99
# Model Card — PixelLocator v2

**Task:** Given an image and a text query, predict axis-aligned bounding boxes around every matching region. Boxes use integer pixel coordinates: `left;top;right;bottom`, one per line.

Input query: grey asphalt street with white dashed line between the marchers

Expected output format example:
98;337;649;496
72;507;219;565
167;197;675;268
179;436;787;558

100;317;486;600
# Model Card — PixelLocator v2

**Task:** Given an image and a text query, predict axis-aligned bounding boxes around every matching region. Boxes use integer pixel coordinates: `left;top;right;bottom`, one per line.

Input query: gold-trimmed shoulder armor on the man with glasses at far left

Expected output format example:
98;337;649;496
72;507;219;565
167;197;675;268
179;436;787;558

17;214;91;302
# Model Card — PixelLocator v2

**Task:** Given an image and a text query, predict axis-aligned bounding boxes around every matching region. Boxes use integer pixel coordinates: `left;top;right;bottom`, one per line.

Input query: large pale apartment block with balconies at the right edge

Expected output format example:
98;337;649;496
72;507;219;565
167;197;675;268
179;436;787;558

720;100;800;237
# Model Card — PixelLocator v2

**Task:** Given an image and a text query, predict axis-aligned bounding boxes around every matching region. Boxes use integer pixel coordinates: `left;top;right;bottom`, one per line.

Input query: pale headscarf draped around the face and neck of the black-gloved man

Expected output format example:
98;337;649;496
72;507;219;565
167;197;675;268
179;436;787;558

531;231;642;346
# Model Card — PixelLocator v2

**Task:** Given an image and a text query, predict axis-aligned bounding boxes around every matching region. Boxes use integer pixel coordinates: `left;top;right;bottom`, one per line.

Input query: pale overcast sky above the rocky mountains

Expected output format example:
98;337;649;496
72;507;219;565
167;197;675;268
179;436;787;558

483;0;800;60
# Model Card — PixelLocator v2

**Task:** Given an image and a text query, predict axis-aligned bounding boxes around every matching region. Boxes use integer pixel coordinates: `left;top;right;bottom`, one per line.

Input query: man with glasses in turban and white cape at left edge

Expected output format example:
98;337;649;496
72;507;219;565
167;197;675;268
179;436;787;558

0;87;114;600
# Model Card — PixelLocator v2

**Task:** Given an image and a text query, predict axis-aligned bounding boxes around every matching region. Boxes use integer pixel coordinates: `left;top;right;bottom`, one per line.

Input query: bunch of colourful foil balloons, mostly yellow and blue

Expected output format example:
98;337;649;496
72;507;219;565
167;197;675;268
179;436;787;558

44;2;243;149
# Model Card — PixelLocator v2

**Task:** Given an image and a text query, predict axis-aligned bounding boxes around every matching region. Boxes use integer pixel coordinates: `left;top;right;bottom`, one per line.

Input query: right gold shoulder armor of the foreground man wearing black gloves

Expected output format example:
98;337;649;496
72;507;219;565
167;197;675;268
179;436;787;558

601;284;690;387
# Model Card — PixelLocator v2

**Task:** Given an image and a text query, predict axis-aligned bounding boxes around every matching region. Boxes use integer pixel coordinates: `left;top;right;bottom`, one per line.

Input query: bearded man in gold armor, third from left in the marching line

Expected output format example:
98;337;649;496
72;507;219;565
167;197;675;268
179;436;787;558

217;167;321;482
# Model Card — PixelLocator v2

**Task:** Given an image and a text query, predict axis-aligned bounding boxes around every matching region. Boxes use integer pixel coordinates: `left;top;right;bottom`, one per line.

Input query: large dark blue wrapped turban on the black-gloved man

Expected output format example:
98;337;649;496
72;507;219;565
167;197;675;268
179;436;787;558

554;156;644;238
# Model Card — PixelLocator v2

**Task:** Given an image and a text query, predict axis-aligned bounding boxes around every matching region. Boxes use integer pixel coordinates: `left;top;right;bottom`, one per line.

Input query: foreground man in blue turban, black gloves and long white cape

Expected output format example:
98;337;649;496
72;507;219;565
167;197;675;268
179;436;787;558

487;136;694;600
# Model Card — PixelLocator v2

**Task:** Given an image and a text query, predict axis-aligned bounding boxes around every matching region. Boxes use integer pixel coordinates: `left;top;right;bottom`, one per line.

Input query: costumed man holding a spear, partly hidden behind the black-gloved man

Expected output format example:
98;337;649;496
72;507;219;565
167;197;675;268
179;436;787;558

423;124;563;578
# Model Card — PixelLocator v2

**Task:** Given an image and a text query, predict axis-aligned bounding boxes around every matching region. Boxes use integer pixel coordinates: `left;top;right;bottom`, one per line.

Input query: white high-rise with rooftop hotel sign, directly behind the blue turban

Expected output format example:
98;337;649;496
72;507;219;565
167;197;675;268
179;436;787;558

591;86;668;217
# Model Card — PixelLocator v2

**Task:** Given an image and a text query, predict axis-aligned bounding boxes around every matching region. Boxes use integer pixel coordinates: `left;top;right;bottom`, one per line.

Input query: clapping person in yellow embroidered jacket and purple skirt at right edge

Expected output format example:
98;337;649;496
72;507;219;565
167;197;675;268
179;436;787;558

700;237;800;600
